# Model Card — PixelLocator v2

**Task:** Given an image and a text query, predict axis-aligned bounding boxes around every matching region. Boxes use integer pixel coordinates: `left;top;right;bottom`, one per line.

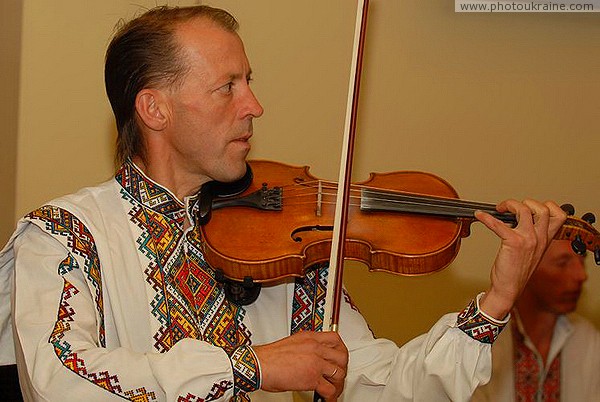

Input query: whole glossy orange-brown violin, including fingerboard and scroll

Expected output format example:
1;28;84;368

198;160;600;283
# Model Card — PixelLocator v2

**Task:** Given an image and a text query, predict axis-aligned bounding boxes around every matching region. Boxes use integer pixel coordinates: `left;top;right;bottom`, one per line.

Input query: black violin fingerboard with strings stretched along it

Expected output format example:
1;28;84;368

360;188;517;225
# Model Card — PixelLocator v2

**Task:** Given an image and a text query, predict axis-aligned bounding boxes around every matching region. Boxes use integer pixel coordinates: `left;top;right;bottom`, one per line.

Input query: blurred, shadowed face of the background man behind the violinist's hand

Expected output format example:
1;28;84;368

526;240;587;314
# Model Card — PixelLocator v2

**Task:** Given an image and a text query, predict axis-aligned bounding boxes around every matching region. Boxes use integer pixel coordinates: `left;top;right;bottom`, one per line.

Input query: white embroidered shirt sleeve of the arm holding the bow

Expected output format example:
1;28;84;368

12;225;244;401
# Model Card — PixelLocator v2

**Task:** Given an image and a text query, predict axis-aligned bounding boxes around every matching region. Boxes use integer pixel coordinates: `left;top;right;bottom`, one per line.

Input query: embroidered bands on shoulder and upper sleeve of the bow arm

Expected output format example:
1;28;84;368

28;206;156;401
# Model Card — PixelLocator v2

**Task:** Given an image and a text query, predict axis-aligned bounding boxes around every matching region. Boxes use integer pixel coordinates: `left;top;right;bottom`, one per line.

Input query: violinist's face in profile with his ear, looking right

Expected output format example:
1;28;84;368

159;19;263;183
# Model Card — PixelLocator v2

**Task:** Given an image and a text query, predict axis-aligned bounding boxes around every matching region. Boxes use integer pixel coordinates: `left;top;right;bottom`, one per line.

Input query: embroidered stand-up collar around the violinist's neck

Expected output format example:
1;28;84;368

115;160;198;219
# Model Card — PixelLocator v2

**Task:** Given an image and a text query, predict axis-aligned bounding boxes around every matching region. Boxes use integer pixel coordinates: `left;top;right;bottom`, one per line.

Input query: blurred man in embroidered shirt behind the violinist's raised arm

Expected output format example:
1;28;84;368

472;240;600;402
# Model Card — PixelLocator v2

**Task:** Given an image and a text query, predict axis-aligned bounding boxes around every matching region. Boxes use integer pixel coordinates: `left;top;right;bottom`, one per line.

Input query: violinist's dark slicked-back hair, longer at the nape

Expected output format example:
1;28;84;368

104;6;238;165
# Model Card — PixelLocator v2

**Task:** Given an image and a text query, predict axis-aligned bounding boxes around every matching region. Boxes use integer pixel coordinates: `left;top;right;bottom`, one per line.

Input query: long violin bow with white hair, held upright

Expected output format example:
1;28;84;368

314;0;369;402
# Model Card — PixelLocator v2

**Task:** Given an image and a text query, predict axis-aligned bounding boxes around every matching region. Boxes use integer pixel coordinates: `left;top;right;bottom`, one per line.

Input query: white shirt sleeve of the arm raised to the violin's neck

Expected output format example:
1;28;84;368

340;288;491;402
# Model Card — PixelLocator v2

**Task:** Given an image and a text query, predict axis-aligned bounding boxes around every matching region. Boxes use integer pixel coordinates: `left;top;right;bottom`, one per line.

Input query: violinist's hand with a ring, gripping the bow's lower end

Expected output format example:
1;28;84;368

252;331;348;401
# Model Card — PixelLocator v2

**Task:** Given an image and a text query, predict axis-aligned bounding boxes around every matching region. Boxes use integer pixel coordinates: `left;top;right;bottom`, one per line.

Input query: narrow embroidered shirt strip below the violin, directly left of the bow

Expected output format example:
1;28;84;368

291;264;329;334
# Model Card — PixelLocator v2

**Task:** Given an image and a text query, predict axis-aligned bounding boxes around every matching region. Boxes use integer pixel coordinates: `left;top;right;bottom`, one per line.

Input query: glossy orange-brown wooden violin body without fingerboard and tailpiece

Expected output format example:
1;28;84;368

201;161;473;282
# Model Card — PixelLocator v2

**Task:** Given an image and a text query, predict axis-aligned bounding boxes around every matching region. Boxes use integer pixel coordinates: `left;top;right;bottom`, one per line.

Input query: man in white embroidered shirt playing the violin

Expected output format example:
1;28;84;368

0;6;565;401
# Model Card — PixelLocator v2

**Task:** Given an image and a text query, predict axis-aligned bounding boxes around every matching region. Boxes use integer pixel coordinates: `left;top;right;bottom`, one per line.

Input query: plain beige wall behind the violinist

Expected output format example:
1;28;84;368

7;0;600;342
